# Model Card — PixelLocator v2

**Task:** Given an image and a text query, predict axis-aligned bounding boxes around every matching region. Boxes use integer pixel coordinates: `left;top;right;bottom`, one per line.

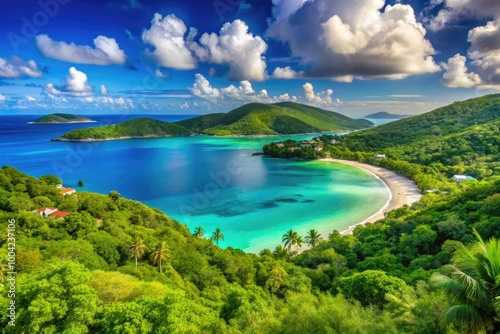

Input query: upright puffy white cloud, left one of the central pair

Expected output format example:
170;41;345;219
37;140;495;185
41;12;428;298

142;13;196;70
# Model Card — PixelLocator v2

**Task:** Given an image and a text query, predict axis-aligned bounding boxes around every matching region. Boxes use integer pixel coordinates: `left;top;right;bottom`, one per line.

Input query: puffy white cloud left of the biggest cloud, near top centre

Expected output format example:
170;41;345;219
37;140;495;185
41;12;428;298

191;20;267;81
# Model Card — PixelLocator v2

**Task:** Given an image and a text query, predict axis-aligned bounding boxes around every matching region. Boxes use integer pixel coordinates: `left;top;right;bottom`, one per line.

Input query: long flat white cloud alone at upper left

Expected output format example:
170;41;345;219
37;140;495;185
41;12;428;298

36;35;127;65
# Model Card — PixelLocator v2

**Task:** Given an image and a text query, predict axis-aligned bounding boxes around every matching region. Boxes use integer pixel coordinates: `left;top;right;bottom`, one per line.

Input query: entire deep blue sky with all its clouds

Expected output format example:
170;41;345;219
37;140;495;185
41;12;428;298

0;0;500;117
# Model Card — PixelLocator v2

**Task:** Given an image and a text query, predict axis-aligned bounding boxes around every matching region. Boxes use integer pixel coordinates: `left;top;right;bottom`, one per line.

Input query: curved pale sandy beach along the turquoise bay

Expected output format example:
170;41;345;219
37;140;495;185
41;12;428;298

322;159;422;234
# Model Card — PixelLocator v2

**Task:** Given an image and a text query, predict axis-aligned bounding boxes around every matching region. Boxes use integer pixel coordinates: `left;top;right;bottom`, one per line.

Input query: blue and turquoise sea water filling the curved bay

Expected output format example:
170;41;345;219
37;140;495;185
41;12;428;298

0;116;389;252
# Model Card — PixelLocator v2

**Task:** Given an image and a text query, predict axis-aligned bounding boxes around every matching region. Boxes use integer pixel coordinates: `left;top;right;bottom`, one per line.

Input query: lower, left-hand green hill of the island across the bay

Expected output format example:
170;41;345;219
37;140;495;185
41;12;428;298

53;118;193;141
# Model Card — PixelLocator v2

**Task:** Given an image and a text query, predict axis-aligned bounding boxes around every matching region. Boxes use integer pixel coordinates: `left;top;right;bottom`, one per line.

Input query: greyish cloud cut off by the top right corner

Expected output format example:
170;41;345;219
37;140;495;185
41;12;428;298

428;0;500;30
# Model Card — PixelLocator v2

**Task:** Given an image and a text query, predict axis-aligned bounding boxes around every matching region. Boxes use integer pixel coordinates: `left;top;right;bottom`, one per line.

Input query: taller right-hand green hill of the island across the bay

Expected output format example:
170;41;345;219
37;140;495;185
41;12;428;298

177;102;373;136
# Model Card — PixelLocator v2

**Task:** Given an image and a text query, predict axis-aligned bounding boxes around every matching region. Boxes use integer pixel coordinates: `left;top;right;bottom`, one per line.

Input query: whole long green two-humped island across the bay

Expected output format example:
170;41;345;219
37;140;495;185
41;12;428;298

53;102;373;141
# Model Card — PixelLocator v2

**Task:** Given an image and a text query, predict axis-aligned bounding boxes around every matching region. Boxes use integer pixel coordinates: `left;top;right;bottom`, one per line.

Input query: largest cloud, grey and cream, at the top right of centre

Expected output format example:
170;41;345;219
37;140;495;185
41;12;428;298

268;0;440;82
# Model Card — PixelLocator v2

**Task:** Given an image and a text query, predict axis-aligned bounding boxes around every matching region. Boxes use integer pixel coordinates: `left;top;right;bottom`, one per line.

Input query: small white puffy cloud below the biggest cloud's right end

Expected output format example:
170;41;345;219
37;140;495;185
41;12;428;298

441;54;481;88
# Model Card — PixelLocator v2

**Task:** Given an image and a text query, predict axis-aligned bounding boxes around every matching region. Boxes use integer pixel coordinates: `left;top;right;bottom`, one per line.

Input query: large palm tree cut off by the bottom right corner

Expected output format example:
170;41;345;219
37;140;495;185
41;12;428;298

433;230;500;333
